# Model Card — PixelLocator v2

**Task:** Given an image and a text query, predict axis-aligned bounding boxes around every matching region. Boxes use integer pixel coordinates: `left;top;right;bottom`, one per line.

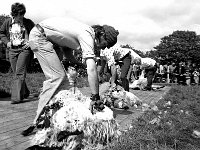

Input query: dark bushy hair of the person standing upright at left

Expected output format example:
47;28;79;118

11;3;26;17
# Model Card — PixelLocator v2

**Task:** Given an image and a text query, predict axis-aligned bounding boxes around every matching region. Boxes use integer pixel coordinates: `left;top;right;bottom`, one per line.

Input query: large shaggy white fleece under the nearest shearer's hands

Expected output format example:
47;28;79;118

32;89;120;150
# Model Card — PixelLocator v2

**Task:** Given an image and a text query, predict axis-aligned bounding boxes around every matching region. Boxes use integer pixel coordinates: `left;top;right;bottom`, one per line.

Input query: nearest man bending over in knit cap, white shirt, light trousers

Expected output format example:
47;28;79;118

22;17;119;136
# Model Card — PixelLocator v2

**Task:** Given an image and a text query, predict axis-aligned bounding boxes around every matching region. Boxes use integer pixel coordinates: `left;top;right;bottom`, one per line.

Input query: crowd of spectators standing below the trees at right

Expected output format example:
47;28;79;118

154;60;199;85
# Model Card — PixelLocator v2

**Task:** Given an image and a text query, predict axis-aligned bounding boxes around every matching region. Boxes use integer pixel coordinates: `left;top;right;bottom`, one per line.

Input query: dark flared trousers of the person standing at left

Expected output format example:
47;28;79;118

9;49;31;101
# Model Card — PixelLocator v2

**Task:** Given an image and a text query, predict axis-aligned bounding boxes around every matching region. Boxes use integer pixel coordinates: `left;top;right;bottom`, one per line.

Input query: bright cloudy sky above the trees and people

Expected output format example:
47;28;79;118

0;0;200;52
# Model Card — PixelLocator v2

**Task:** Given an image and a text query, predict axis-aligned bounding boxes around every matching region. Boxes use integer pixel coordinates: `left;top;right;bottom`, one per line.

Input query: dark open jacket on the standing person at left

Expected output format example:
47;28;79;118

0;18;35;45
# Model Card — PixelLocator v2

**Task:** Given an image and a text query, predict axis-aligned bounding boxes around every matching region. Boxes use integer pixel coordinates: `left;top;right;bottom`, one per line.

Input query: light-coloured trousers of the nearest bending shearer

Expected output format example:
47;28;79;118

29;27;70;124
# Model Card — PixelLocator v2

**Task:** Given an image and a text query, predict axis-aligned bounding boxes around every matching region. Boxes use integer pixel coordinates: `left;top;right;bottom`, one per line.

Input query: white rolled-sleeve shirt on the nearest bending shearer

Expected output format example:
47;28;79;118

39;17;95;59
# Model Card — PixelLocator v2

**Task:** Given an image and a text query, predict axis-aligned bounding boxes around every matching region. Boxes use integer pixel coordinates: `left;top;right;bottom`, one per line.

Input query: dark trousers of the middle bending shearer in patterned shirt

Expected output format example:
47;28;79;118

120;54;131;91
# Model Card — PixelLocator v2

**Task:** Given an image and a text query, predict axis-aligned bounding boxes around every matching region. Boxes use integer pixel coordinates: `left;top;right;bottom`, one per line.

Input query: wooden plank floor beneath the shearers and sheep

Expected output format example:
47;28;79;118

0;87;169;150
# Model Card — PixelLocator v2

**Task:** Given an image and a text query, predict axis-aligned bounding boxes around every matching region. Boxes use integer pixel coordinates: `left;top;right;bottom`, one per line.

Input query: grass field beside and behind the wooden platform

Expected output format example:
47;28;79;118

0;73;200;150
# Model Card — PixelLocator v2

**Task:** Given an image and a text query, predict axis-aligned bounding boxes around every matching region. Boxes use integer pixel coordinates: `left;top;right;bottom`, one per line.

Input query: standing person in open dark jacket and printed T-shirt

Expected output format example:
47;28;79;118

0;3;34;104
